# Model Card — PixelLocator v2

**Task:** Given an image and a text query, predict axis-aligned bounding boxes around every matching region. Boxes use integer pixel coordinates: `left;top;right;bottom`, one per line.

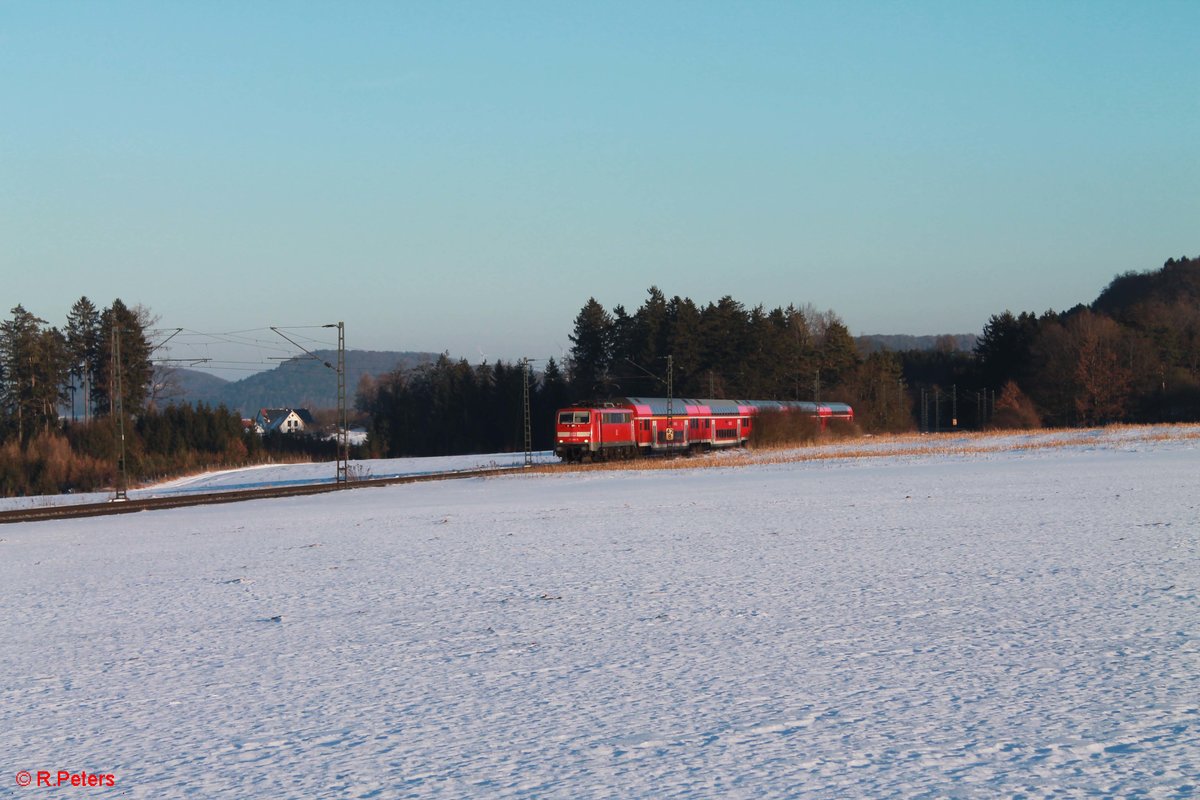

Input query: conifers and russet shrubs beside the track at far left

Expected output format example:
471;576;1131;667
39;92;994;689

0;297;348;497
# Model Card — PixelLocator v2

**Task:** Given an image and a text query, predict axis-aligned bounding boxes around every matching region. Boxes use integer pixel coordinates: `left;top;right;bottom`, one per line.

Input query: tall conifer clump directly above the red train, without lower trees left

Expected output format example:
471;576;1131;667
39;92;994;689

569;287;911;431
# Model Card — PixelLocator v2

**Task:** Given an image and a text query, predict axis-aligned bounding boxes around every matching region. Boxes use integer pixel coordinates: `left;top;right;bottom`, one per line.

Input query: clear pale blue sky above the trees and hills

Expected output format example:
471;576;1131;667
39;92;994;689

0;0;1200;371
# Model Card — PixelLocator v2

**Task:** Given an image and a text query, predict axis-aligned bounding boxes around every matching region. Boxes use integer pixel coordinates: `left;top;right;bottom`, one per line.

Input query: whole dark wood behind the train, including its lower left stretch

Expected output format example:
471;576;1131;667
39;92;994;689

356;287;911;457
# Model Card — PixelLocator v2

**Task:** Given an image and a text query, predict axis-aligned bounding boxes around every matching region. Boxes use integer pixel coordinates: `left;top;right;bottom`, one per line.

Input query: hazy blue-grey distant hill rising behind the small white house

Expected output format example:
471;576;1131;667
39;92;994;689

156;350;438;416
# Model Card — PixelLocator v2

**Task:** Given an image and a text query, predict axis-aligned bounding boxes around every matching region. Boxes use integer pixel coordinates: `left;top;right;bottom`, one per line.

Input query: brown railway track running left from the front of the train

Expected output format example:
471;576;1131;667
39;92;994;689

0;467;535;524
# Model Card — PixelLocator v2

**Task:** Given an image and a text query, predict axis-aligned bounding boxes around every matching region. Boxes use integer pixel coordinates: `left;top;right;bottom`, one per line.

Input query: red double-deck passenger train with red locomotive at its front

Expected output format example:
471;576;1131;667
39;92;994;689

554;397;854;462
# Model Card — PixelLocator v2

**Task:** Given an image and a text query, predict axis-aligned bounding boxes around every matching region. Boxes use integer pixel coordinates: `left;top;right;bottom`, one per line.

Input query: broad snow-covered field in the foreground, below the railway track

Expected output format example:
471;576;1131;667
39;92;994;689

0;428;1200;798
